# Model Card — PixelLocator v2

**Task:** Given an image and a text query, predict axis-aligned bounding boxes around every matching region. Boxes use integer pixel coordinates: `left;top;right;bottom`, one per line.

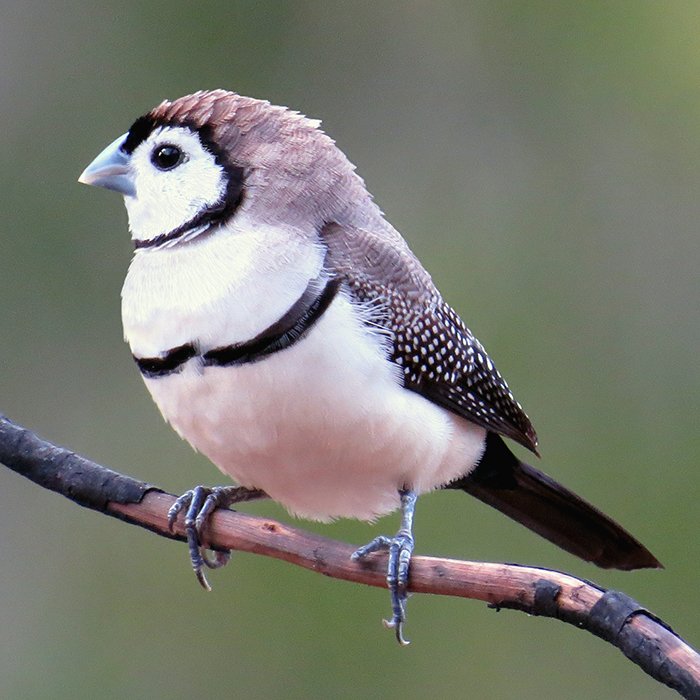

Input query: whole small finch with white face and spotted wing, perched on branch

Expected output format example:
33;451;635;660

79;89;661;644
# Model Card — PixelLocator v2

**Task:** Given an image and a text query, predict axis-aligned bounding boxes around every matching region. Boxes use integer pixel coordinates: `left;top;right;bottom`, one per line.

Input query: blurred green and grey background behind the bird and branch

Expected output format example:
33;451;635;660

0;0;700;700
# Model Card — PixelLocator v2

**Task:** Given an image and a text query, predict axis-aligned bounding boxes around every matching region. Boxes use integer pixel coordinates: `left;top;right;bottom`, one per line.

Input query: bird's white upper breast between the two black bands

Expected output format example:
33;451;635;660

122;212;324;357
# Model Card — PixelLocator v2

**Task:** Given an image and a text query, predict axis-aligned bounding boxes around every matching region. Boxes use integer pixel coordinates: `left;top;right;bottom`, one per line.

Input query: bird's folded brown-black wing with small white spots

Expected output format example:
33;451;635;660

322;220;537;453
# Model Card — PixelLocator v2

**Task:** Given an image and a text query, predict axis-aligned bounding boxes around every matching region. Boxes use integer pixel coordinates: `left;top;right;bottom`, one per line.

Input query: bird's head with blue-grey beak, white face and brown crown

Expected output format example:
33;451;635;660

80;90;368;248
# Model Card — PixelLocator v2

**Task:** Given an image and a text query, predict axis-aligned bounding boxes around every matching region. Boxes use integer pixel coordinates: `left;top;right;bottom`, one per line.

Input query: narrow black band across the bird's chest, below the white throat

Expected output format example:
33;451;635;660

134;277;341;379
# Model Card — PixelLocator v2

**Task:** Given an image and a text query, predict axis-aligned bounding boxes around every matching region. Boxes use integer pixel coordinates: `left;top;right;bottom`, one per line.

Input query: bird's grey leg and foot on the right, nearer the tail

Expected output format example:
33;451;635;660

352;489;418;644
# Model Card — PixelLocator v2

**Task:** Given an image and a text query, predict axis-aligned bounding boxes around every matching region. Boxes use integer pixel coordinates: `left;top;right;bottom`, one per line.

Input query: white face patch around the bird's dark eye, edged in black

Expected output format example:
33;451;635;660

124;126;226;245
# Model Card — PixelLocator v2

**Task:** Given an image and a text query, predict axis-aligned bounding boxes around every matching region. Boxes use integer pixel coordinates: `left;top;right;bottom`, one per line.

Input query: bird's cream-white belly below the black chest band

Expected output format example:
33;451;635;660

139;297;485;520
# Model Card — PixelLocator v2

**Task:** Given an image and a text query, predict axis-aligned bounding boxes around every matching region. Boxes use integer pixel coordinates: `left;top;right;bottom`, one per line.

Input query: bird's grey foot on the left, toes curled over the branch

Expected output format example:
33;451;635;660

168;486;267;591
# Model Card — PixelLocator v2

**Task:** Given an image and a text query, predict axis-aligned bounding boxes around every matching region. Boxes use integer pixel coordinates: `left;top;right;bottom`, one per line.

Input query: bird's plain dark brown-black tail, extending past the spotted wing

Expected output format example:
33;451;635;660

447;433;663;571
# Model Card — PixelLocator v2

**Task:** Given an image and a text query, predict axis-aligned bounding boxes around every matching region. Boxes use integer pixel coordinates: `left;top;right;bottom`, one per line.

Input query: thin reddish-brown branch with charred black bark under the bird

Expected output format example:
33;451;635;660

0;416;700;700
